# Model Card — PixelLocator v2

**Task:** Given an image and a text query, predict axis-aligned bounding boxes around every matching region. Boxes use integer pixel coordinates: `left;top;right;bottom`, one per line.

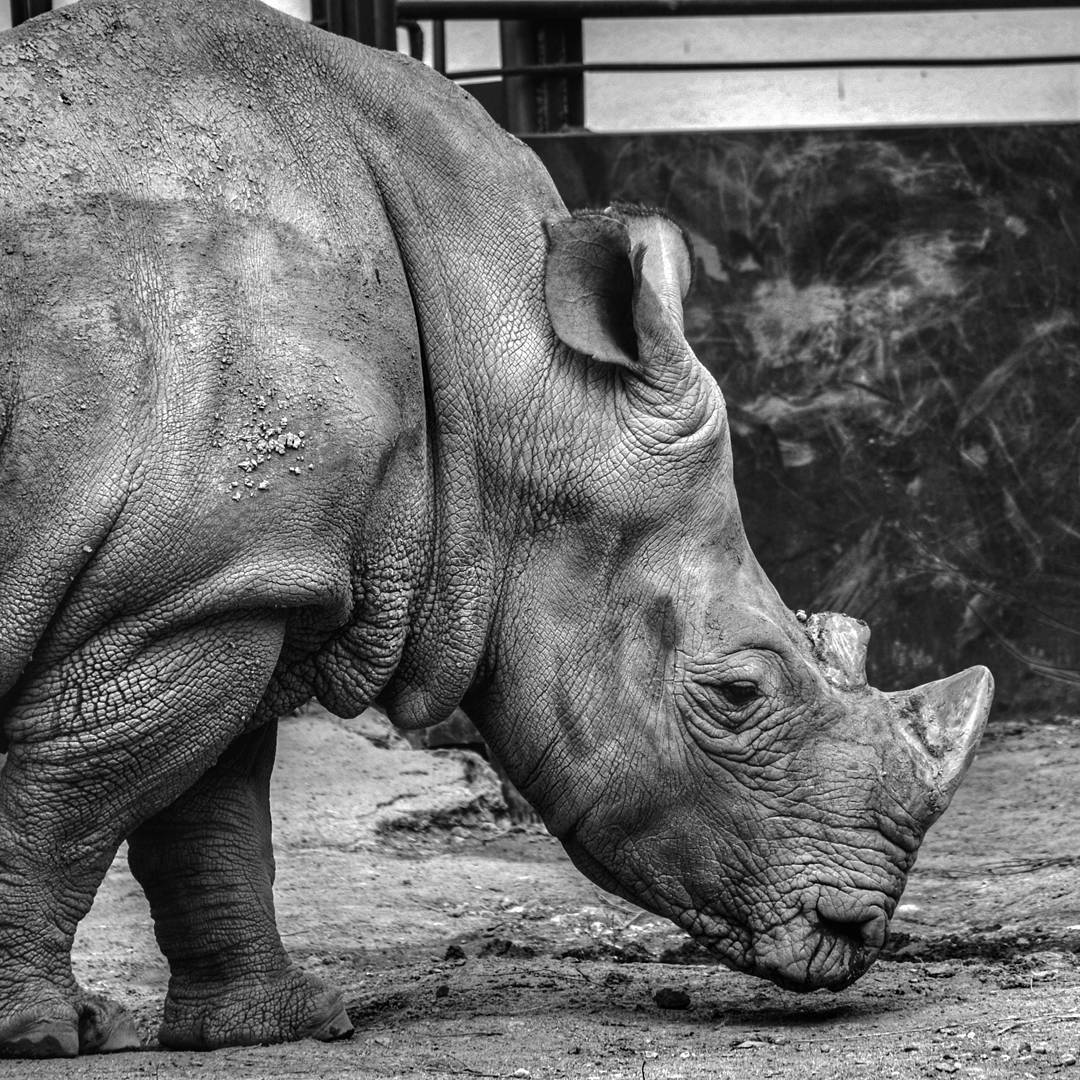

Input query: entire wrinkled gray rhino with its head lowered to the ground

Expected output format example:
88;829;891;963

0;0;990;1055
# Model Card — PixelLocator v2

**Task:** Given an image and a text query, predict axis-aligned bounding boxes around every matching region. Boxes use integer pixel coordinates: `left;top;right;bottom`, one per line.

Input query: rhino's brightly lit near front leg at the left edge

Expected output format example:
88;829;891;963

0;613;283;1057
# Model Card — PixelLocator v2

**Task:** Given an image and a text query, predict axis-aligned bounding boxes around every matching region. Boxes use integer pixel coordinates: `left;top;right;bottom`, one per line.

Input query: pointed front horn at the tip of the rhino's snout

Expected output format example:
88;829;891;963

888;666;994;827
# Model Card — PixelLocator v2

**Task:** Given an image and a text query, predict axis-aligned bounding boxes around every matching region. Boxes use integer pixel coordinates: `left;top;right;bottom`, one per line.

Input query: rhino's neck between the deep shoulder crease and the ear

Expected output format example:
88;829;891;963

350;61;566;727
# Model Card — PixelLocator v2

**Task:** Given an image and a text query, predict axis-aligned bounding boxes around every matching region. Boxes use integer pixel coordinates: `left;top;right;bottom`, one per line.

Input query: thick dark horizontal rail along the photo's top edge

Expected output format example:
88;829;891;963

397;0;1080;19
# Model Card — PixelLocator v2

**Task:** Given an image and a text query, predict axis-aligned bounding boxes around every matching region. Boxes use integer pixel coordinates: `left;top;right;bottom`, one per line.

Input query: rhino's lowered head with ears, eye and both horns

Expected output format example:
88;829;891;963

470;207;993;989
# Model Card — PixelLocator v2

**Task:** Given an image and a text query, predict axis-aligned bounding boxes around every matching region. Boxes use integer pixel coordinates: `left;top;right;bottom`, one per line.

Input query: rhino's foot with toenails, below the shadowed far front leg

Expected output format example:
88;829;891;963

158;968;352;1050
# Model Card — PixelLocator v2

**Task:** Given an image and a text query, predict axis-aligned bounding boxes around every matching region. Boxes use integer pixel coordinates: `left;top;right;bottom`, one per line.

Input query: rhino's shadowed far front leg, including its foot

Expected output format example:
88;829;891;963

129;721;352;1050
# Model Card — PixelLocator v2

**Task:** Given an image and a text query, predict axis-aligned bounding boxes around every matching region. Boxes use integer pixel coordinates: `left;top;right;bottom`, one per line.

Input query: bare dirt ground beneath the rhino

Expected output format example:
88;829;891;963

8;714;1080;1080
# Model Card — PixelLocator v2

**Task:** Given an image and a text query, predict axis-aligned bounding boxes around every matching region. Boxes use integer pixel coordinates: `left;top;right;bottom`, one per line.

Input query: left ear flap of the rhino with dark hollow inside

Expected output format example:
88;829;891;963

544;214;637;368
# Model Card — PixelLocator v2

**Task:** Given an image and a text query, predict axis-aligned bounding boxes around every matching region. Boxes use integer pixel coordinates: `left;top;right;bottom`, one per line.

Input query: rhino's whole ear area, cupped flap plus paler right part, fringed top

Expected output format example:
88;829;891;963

544;206;692;373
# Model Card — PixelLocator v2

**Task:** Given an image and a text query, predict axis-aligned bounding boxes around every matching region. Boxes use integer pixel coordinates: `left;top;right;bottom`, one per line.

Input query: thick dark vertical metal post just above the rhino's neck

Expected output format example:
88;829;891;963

499;18;585;134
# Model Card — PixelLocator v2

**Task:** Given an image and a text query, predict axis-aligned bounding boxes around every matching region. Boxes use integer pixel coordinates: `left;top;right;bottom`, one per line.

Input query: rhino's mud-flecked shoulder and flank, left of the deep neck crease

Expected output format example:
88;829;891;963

0;0;453;717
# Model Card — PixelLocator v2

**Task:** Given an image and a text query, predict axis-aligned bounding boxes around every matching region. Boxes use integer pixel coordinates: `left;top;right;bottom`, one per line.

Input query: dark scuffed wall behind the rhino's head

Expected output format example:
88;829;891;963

532;126;1080;712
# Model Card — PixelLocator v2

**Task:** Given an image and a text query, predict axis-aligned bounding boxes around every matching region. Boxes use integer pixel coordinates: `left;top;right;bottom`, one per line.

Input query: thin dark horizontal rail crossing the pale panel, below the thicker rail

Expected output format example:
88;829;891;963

446;53;1080;82
